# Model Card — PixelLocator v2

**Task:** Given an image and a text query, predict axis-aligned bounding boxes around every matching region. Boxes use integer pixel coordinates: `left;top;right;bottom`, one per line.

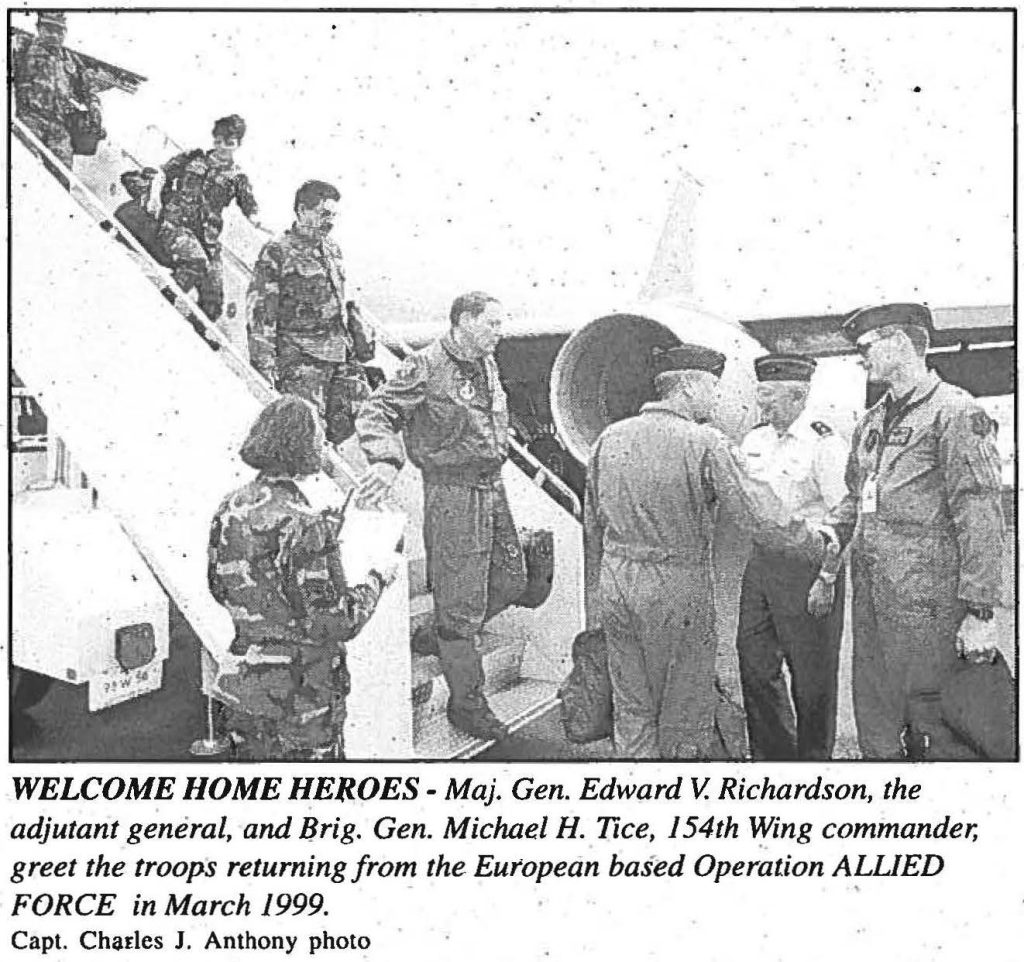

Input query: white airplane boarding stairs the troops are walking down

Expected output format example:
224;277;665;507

12;114;583;758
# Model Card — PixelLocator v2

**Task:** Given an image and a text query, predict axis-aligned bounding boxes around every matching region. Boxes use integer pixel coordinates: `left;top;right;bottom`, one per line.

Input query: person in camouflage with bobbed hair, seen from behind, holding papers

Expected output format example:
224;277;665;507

209;395;395;760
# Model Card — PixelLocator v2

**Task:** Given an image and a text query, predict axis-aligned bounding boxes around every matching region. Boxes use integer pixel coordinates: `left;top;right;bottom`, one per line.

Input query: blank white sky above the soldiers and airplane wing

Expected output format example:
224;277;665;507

18;12;1013;325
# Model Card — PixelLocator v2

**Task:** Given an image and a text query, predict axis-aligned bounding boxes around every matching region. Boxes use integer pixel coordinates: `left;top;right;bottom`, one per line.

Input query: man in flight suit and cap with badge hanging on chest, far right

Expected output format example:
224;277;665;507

810;304;1004;759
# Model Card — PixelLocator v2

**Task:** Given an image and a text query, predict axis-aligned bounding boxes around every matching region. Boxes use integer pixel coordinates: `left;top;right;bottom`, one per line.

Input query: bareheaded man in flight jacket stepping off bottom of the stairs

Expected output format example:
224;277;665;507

355;291;526;740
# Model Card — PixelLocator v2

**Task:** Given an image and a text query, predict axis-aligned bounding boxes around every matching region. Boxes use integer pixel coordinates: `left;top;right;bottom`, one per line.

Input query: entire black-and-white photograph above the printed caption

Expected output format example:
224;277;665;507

7;7;1019;762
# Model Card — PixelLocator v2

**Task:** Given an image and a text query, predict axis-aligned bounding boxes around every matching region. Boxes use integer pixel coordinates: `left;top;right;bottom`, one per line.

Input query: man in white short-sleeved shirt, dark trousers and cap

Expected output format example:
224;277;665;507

736;354;847;761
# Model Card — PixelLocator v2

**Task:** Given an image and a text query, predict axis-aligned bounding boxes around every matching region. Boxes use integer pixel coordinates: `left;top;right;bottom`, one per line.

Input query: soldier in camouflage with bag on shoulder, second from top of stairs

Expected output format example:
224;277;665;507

159;114;259;321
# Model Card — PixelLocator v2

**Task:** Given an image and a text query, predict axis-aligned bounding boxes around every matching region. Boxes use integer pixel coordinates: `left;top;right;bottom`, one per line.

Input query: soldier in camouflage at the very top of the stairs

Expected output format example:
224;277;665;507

14;11;105;169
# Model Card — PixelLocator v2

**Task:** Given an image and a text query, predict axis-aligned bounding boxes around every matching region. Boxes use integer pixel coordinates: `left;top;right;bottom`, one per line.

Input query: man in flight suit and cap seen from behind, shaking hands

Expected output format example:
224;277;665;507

584;344;822;758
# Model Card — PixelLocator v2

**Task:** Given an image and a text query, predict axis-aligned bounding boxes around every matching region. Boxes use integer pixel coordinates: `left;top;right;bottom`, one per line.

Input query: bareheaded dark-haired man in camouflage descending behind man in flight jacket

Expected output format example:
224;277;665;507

248;180;374;444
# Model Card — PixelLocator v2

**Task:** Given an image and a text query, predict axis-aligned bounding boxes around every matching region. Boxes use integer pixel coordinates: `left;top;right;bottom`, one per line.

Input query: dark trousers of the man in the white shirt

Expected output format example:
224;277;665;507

736;545;846;761
